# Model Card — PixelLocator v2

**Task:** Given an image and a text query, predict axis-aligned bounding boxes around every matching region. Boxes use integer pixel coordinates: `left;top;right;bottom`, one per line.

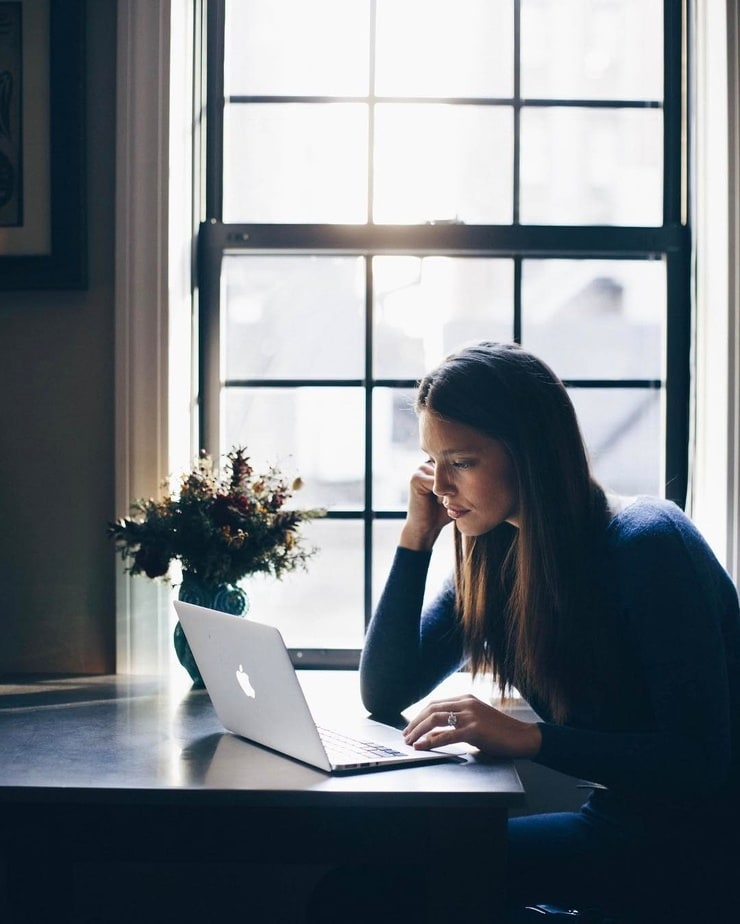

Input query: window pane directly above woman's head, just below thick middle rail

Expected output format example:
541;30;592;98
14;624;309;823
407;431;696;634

373;256;514;379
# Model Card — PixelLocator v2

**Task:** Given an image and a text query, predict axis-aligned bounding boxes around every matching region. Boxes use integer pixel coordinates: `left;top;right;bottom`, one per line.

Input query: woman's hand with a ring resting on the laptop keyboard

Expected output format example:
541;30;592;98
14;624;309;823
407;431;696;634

403;694;542;758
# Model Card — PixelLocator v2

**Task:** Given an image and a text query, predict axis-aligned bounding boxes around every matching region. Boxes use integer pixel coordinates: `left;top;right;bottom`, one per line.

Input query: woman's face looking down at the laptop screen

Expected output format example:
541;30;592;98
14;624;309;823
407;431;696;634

419;411;519;536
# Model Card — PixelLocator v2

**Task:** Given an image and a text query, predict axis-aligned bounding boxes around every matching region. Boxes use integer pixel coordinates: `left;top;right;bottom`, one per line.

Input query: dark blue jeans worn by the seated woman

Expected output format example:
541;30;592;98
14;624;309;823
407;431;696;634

507;803;740;924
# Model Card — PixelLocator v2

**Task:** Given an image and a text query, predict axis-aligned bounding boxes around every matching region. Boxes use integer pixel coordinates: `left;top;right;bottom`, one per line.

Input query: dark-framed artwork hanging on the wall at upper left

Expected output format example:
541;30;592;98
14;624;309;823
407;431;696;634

0;0;87;290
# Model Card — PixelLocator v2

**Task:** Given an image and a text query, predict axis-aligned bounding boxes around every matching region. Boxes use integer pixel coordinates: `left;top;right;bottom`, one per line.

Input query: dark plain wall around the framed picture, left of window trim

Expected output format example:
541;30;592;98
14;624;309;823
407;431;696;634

0;0;116;674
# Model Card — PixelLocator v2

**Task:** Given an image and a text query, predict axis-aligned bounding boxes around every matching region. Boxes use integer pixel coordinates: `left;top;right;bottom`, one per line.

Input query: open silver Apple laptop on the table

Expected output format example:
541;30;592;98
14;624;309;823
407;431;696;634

174;600;465;773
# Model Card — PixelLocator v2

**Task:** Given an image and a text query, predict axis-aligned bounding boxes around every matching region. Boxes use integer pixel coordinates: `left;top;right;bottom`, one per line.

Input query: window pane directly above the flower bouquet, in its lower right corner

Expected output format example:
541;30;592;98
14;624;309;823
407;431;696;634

221;388;365;509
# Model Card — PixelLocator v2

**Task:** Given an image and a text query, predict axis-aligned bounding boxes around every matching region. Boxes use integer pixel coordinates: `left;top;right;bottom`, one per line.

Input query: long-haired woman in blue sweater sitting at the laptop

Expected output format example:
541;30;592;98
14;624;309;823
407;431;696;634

360;343;740;924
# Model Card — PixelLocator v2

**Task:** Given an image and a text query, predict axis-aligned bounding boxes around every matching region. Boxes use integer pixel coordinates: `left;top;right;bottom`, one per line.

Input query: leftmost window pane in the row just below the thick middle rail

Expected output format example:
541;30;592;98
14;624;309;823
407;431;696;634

222;254;365;379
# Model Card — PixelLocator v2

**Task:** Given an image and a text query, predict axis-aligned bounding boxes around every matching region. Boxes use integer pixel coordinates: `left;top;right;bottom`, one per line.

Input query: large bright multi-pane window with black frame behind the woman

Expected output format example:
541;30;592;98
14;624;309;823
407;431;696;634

198;0;691;666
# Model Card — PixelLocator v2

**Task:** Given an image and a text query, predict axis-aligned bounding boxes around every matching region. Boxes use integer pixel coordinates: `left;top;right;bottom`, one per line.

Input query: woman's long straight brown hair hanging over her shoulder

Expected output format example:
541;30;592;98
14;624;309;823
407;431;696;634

416;342;616;721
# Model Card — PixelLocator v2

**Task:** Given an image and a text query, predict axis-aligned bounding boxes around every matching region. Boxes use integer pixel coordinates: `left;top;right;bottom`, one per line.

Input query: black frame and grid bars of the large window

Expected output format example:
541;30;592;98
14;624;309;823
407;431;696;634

196;0;693;668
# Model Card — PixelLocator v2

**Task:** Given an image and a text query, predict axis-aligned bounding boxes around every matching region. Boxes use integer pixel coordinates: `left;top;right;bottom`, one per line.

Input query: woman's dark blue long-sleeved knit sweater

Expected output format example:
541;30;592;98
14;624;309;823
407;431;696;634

360;497;740;826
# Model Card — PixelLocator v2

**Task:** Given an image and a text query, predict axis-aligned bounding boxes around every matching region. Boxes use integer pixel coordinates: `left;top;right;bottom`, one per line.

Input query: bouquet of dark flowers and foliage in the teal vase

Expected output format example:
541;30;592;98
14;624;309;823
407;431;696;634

108;447;325;584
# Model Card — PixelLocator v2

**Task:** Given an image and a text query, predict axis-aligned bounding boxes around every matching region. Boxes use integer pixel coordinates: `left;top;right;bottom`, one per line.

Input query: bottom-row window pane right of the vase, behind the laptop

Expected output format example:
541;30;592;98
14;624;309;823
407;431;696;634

249;519;364;648
